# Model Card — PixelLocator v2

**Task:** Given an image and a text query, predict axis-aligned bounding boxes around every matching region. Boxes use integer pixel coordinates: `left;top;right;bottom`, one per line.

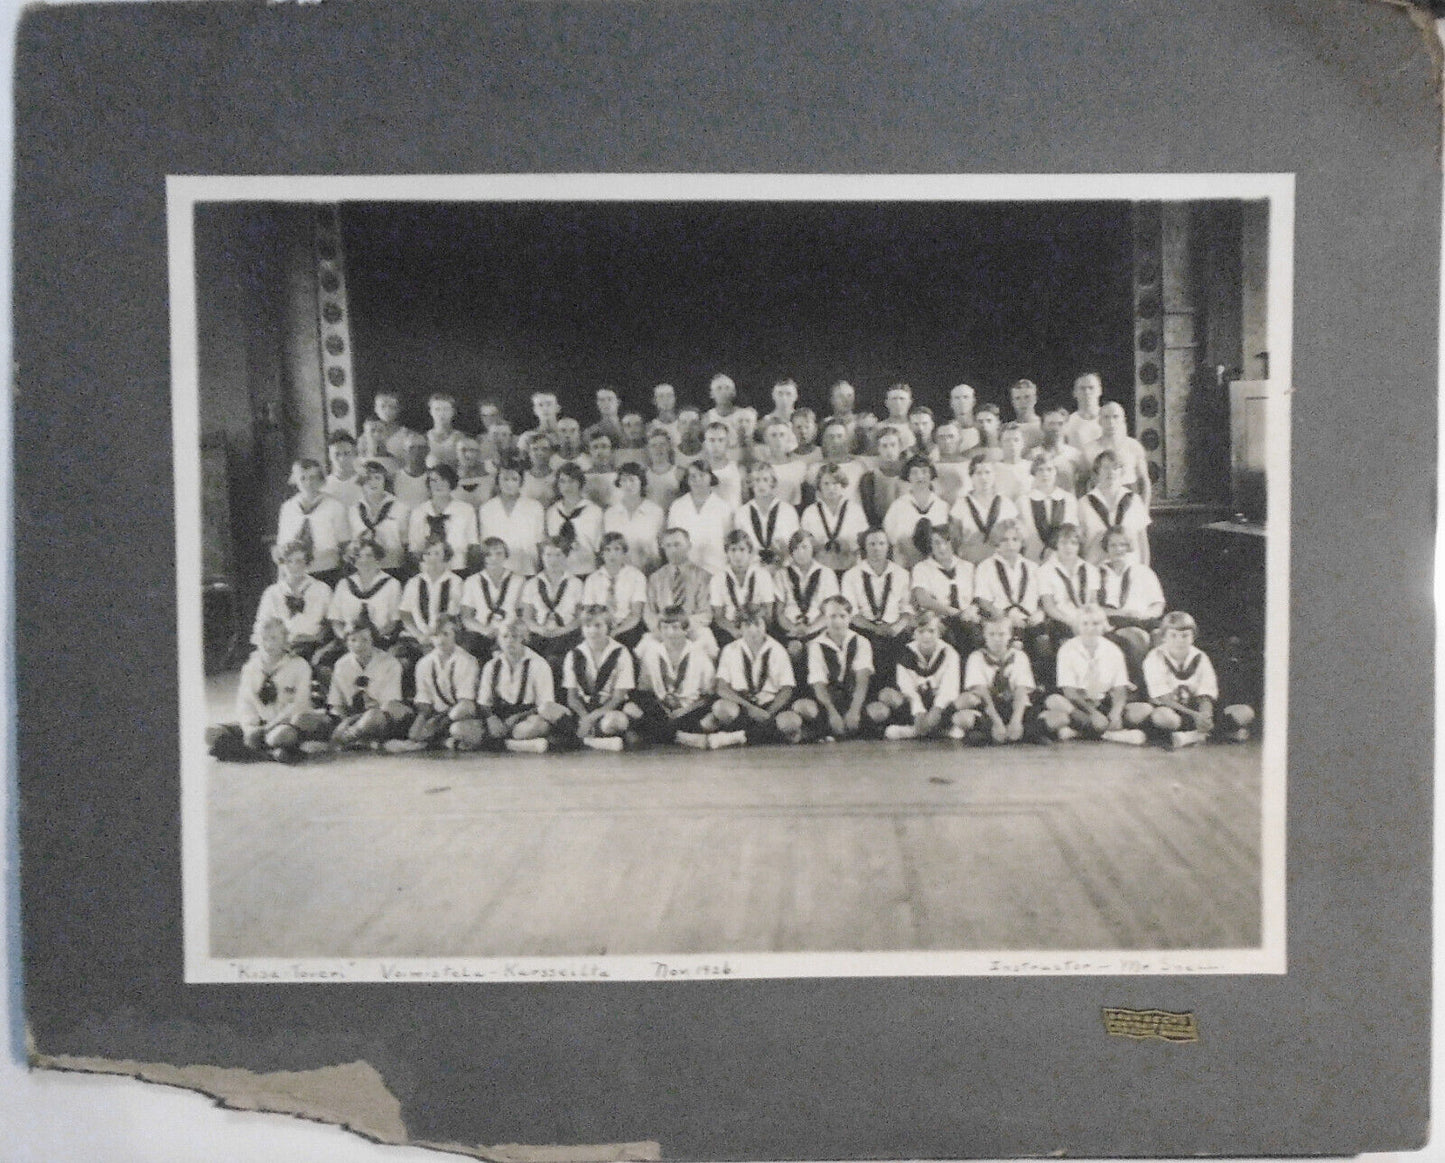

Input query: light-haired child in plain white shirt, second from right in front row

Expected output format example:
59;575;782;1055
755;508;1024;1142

1042;602;1147;747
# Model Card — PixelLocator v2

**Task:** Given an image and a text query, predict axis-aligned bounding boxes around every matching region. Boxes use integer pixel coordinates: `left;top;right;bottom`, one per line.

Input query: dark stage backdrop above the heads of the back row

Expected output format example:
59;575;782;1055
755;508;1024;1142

342;202;1133;426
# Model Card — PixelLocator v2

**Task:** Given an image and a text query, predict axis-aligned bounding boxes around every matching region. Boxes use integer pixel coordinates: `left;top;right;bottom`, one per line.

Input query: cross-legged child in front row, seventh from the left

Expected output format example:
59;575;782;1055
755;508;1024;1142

705;603;803;747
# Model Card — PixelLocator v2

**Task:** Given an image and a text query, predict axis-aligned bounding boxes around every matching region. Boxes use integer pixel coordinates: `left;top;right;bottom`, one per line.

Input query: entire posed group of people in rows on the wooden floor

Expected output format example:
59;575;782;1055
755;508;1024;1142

208;373;1253;761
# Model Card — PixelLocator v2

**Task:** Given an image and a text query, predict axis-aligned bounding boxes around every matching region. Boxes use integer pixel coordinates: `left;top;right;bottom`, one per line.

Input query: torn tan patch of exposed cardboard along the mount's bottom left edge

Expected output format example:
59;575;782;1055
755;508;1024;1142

30;1053;662;1163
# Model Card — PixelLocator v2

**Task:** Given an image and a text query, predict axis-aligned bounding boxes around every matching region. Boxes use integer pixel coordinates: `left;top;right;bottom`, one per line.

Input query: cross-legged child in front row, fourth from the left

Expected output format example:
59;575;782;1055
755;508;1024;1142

451;617;565;754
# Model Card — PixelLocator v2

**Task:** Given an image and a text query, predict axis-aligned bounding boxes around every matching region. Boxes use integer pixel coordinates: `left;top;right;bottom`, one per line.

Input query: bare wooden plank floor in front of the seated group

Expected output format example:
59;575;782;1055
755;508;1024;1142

197;670;1260;958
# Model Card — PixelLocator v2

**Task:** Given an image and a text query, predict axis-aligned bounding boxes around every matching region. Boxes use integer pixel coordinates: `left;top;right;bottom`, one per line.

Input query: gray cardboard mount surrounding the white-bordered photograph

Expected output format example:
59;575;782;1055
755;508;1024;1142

14;0;1441;1159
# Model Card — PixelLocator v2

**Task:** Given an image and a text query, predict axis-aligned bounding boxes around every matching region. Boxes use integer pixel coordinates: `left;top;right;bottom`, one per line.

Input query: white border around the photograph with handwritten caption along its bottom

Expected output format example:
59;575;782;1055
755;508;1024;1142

166;173;1295;984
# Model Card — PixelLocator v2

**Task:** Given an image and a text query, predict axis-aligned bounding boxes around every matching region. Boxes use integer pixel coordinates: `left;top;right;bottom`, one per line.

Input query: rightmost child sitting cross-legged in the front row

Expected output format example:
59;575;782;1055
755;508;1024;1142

1143;610;1254;747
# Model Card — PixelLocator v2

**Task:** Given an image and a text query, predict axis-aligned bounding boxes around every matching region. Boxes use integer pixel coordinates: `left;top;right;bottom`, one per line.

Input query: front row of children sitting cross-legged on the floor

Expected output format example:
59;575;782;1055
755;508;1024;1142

207;595;1253;761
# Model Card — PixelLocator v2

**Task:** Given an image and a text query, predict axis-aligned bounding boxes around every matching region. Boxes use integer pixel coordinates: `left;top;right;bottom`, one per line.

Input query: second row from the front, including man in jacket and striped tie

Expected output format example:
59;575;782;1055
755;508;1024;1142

253;502;1165;702
